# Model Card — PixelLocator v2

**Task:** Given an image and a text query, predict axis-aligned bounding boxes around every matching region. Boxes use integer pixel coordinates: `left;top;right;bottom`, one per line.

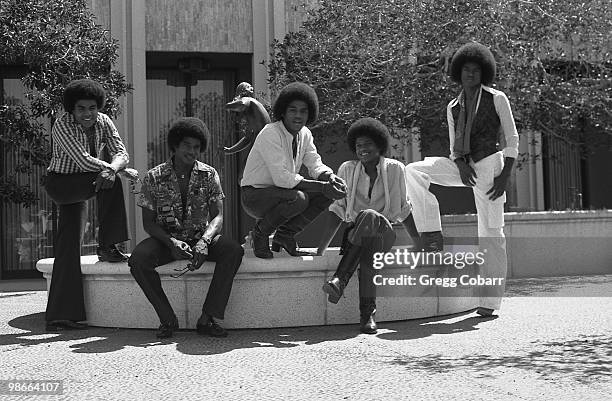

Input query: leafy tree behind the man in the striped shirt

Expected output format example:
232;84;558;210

0;0;130;206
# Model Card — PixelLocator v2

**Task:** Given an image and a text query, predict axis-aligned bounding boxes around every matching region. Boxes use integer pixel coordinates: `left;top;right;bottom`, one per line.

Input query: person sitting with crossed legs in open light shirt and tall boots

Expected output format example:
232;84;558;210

318;118;411;334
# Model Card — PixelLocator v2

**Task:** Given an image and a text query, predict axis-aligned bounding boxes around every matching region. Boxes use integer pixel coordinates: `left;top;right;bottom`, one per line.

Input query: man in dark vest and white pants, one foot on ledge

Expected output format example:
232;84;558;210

406;42;519;316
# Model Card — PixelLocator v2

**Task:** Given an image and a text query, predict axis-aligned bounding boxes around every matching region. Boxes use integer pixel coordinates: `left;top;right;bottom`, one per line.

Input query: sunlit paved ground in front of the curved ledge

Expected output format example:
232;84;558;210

0;275;612;401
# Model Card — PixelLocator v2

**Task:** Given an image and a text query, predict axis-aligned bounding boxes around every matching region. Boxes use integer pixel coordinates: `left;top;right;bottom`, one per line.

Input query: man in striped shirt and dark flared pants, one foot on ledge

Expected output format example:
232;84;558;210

44;79;136;331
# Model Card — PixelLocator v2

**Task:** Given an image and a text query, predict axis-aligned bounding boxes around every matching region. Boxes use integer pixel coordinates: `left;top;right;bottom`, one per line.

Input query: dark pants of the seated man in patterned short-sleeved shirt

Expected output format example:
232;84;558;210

128;235;244;323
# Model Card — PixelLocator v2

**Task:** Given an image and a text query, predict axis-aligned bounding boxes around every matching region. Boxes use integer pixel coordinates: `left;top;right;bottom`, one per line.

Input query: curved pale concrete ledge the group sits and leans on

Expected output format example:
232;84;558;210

36;248;477;328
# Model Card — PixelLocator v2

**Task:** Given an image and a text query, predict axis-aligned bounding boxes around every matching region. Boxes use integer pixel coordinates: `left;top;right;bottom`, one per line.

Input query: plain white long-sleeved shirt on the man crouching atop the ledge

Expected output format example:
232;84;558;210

240;121;333;188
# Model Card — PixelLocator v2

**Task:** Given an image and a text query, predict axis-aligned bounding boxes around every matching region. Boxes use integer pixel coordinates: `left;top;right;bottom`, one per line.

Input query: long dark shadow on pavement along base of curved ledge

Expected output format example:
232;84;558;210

0;313;496;355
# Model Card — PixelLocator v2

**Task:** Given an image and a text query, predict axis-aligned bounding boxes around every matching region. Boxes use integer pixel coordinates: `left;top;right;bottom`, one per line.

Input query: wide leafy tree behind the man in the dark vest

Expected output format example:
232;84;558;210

269;0;612;163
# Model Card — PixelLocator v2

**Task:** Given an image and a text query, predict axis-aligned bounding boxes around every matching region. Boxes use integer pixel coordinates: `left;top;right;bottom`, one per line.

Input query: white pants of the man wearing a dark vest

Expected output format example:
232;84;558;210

406;152;508;309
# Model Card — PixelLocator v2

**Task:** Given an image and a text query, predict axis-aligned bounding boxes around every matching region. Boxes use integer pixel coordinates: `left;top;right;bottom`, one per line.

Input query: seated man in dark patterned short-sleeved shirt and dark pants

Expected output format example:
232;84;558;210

128;117;244;338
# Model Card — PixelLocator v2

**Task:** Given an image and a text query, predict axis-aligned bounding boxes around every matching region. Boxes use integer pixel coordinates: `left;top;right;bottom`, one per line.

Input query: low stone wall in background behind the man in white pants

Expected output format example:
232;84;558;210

442;210;612;278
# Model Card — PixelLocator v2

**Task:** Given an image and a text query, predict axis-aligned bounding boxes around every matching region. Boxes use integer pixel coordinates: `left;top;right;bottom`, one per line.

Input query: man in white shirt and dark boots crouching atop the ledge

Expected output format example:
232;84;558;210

240;82;346;259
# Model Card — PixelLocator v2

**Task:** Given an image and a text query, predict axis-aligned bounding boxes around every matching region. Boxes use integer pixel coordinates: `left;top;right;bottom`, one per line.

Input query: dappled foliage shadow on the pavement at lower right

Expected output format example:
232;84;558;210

391;335;612;384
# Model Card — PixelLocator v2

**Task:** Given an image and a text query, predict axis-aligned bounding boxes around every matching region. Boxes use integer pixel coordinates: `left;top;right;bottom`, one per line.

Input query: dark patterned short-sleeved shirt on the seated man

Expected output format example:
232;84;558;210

137;159;225;242
